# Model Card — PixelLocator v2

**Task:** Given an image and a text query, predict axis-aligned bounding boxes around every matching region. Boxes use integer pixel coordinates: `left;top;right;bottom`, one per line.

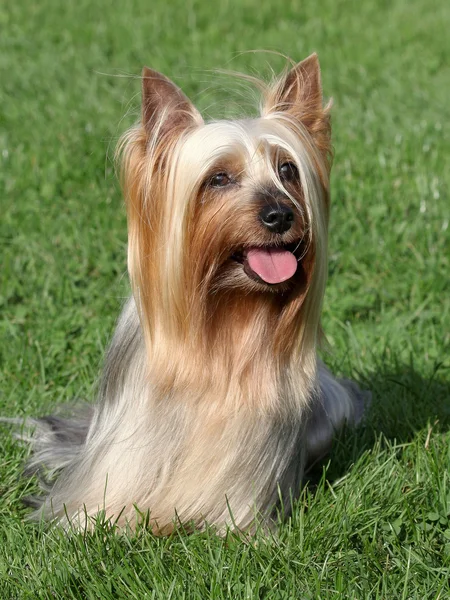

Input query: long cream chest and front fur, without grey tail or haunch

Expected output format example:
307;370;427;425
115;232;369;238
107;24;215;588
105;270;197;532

64;300;305;531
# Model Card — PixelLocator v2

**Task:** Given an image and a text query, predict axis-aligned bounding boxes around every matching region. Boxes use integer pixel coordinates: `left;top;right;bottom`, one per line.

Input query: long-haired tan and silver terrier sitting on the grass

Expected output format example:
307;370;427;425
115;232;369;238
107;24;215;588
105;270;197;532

14;54;366;535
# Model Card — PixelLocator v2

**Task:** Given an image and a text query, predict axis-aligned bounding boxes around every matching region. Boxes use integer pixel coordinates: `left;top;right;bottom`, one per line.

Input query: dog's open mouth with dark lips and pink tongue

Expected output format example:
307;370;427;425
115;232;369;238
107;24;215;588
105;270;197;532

232;242;305;285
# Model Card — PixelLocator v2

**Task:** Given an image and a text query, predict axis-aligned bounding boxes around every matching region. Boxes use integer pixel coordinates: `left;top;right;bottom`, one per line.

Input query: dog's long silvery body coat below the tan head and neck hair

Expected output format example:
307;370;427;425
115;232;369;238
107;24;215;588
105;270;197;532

22;299;365;531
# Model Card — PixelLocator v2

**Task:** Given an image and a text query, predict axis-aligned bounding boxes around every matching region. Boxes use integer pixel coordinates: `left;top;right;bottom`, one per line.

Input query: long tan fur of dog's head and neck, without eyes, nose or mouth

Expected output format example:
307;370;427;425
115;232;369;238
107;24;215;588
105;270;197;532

119;55;329;410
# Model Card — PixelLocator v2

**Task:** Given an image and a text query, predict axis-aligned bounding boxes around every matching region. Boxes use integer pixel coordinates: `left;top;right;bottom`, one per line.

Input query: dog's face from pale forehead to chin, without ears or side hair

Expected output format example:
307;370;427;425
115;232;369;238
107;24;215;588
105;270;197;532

188;119;314;294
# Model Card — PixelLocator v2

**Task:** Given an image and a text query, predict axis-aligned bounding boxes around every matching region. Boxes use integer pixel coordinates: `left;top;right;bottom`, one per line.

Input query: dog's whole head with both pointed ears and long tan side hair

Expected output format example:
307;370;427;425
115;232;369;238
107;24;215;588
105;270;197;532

119;55;330;360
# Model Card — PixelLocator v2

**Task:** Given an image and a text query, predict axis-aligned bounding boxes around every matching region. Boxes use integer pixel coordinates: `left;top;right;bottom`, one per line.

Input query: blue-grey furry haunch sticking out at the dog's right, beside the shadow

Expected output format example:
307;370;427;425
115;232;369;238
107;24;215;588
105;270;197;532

306;363;371;467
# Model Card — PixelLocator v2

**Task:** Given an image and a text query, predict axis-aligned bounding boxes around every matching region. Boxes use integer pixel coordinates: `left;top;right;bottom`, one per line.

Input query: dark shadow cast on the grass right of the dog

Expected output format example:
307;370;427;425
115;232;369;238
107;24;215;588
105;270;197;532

307;364;450;486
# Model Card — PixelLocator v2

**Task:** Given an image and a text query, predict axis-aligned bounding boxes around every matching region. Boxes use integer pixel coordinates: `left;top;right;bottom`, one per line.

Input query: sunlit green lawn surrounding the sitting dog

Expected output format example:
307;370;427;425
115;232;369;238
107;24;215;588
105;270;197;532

0;0;450;600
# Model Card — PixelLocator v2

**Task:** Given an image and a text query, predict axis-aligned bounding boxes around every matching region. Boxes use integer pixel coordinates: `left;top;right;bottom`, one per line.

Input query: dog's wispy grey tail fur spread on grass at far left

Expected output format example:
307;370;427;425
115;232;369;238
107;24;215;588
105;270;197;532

0;405;94;508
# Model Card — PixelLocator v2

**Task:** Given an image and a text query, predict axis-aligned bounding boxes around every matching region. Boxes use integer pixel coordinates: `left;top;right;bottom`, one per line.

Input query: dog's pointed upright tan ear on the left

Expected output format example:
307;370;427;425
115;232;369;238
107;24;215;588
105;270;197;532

142;67;203;137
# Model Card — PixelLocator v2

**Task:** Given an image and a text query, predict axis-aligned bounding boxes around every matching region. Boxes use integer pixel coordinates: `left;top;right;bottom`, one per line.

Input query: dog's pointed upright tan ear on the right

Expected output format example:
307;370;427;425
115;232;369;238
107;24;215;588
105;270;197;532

262;53;331;145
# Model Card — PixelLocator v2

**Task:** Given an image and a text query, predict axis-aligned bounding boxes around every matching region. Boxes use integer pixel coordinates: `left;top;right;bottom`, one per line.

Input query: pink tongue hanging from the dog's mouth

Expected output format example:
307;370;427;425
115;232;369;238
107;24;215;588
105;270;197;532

247;248;297;283
